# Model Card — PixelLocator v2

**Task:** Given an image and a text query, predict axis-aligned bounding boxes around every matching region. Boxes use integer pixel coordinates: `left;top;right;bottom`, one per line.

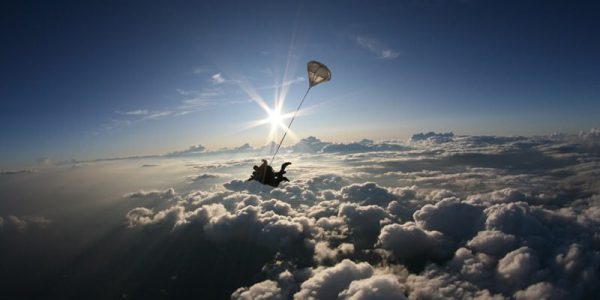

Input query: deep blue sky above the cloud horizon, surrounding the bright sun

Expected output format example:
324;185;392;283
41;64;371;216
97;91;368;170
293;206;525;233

0;1;600;167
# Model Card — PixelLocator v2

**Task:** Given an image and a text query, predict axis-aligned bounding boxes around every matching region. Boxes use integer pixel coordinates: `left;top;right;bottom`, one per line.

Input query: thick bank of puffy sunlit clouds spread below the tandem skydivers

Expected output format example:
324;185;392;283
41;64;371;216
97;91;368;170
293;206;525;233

9;133;600;299
